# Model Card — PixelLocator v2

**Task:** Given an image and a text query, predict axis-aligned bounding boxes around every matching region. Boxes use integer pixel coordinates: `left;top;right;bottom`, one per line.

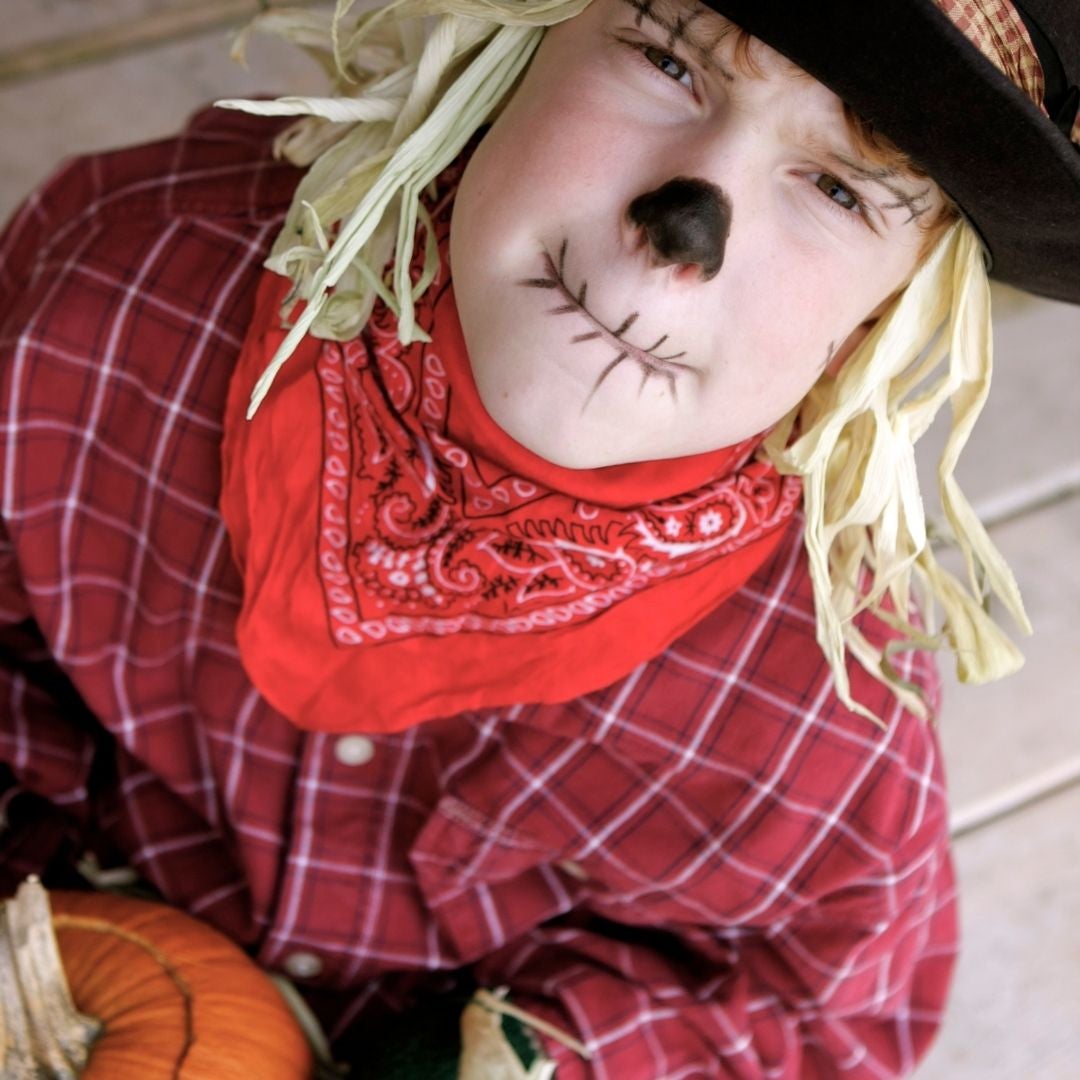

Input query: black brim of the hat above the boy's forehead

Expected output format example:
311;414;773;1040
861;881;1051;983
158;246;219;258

705;0;1080;302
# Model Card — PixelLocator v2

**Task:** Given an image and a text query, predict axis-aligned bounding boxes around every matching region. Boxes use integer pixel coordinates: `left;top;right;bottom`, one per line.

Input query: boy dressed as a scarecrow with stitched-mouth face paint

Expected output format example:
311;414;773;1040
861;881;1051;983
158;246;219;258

3;0;1080;1078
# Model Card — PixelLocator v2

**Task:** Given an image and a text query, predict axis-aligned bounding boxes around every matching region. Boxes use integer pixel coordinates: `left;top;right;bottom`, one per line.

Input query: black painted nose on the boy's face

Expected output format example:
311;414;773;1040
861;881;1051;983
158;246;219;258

626;176;731;281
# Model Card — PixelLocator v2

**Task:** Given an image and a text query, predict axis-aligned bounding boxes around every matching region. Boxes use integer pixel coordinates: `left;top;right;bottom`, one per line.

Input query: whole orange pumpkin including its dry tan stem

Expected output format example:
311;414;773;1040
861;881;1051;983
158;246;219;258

0;875;315;1080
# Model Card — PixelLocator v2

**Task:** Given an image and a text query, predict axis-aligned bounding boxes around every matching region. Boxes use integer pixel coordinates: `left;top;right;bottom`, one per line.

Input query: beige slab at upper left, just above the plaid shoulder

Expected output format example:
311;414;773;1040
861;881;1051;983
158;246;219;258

0;23;325;219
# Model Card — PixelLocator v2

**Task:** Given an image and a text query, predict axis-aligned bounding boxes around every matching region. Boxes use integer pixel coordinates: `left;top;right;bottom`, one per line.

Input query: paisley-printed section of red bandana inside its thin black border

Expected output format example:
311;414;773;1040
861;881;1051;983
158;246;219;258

316;287;798;645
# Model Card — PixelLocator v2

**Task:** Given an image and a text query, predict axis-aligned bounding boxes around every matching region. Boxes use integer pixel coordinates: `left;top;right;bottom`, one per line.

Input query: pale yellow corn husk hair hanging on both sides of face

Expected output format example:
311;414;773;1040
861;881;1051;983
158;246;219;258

217;0;1030;719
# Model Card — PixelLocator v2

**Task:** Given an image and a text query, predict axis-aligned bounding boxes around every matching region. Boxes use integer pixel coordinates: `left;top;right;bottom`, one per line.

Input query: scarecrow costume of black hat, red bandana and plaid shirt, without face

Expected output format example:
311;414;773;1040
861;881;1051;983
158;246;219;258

0;0;1080;1080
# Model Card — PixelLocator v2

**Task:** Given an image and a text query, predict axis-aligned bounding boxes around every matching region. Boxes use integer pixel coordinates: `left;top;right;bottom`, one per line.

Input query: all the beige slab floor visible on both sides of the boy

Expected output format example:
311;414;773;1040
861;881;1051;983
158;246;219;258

6;0;1080;1080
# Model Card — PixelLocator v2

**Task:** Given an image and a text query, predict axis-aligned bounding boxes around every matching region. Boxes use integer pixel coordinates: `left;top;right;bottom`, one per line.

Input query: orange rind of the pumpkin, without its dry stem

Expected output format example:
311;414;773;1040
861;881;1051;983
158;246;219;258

0;882;313;1080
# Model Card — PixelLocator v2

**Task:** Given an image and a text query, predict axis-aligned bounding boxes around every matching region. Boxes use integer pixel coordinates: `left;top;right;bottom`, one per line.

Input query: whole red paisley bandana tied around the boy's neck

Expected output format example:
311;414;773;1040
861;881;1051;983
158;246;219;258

221;157;800;731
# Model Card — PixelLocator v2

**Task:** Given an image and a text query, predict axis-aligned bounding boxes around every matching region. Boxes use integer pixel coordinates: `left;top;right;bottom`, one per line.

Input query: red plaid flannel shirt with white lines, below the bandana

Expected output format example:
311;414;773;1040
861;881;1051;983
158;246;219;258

0;105;956;1080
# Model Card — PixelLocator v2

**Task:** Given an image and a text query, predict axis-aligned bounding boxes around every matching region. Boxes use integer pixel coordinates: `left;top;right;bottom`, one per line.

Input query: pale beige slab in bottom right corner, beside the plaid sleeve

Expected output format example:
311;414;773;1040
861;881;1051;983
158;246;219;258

918;788;1080;1080
